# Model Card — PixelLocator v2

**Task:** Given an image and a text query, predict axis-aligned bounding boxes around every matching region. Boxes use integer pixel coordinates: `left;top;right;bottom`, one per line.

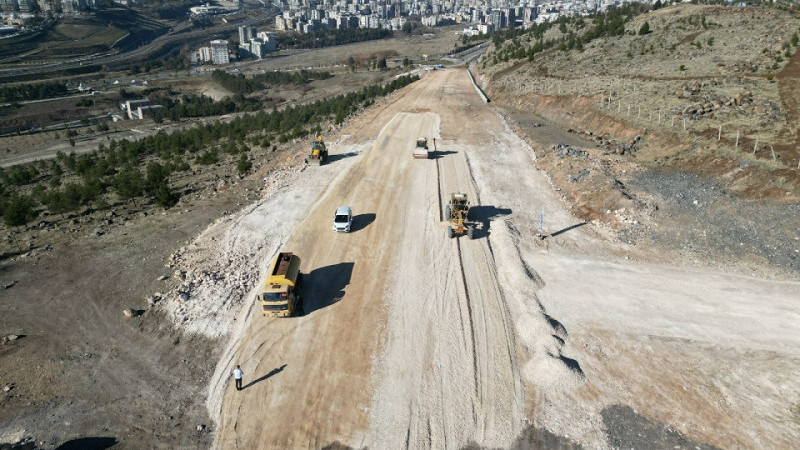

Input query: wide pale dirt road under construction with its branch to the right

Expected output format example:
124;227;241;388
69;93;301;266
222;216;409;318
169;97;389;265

197;69;800;448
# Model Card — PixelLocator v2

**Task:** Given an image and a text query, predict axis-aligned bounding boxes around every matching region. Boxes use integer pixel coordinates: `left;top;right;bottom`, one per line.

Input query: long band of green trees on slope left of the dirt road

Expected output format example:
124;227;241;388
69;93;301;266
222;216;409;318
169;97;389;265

0;76;419;226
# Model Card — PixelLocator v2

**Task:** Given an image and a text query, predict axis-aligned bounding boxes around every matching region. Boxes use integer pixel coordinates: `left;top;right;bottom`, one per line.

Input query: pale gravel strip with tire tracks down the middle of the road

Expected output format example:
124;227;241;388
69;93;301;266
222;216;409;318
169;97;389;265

370;71;524;449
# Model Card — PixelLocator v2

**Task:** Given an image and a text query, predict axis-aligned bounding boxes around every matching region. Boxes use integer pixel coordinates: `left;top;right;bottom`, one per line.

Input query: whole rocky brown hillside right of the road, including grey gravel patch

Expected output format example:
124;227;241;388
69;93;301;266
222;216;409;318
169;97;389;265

474;4;800;274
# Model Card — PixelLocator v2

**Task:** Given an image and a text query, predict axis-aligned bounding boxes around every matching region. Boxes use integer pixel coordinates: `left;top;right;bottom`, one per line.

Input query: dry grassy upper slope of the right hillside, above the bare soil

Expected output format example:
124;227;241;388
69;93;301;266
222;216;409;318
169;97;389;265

484;5;800;201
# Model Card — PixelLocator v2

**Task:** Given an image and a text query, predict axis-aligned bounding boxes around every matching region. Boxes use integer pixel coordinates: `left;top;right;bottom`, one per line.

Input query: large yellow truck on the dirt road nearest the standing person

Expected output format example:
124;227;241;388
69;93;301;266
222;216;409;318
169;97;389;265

258;252;303;317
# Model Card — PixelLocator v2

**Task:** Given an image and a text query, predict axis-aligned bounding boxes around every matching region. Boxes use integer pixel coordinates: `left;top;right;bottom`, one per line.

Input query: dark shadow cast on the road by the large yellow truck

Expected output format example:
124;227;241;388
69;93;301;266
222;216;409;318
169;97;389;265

303;262;355;315
